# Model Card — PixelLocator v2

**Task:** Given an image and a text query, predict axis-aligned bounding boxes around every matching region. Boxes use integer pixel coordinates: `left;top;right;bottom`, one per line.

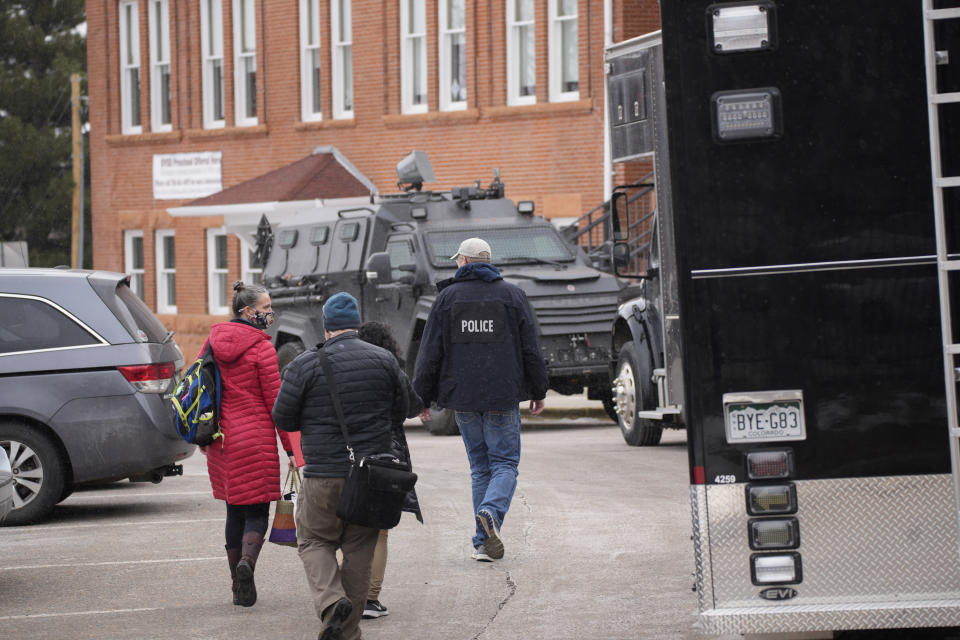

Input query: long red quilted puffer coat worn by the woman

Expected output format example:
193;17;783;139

200;322;293;504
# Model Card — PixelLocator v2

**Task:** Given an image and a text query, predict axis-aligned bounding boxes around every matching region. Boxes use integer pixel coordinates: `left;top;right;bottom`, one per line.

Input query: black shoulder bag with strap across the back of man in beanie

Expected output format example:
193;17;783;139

317;349;417;529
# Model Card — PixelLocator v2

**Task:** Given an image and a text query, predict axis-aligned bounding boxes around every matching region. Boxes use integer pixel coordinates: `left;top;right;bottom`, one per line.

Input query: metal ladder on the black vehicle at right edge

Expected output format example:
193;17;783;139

923;0;960;553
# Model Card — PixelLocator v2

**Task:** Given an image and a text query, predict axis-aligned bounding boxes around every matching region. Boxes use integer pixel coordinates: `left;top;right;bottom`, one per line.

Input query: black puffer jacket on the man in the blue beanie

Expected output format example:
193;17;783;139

273;332;409;478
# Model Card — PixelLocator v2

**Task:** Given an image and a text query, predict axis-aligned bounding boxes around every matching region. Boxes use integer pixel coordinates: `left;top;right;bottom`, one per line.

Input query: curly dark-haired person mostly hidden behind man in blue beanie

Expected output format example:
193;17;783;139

357;321;423;618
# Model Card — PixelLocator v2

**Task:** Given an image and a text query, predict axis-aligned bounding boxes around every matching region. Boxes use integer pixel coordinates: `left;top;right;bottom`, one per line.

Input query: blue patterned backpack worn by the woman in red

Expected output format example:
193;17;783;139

171;342;223;447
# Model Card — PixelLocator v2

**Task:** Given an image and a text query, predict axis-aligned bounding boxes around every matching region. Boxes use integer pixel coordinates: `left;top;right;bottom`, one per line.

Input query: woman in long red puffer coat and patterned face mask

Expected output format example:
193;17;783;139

198;281;299;607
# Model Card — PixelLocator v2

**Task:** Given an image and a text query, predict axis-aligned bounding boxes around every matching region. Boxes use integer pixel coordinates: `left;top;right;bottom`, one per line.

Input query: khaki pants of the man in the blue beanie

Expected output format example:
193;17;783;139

296;478;379;640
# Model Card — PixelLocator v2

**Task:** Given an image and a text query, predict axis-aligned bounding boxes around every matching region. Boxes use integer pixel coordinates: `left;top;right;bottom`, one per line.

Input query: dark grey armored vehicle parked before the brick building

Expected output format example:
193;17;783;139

258;151;620;434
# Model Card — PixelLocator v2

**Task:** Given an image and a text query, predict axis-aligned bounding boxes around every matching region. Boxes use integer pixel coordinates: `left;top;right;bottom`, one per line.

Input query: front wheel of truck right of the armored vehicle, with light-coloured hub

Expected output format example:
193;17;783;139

613;342;663;447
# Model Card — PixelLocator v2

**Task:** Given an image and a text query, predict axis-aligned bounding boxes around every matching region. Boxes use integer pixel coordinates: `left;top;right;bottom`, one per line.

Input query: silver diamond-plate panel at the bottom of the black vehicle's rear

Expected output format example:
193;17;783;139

691;475;960;633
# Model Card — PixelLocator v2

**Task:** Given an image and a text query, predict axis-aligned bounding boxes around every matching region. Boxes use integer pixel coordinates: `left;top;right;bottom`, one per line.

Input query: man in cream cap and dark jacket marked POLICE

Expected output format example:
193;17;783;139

413;238;548;562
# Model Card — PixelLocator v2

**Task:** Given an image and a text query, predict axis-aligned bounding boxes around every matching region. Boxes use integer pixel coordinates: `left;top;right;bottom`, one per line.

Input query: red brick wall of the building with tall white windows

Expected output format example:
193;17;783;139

87;0;658;356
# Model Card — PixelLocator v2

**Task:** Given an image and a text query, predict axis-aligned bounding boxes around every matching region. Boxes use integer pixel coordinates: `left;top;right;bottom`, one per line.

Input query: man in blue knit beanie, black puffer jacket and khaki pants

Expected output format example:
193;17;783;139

273;293;408;640
